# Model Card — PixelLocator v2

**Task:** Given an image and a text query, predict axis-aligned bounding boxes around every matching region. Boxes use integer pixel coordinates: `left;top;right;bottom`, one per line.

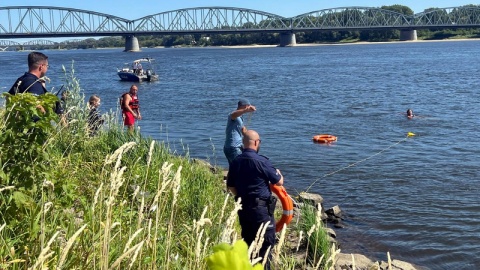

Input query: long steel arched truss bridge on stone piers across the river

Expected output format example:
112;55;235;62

0;5;480;51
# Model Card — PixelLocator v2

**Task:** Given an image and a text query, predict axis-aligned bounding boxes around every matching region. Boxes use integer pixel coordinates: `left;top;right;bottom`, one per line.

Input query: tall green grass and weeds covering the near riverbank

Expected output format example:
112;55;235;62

0;66;329;269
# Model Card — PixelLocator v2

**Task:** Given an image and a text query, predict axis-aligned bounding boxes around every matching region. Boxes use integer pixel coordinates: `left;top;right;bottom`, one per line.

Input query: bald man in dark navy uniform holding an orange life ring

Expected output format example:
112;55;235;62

227;130;283;269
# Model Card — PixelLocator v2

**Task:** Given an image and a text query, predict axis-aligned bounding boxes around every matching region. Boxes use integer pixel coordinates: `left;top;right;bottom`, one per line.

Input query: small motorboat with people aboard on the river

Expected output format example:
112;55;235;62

117;57;158;82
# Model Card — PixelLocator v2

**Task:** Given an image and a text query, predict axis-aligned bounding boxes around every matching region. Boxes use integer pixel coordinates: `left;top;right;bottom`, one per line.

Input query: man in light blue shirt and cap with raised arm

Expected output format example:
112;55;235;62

223;99;256;165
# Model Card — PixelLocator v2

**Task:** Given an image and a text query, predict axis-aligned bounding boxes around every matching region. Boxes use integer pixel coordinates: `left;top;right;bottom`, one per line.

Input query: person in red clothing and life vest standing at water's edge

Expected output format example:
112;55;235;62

121;84;142;134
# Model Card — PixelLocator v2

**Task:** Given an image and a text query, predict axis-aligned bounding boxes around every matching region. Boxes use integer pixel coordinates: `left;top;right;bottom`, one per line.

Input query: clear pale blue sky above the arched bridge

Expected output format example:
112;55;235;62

0;0;480;20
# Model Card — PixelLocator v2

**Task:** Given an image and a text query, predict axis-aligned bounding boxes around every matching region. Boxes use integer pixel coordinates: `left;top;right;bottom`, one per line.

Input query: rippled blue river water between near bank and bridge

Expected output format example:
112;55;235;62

0;41;480;269
